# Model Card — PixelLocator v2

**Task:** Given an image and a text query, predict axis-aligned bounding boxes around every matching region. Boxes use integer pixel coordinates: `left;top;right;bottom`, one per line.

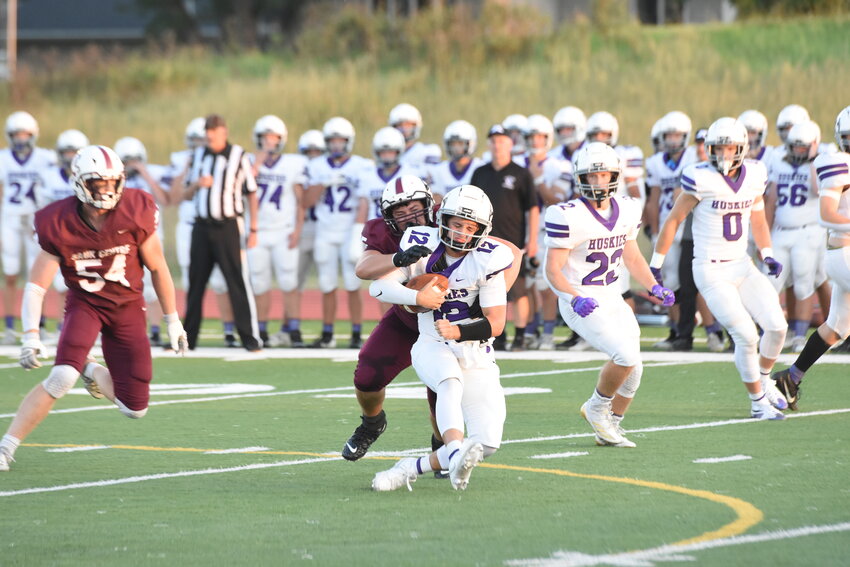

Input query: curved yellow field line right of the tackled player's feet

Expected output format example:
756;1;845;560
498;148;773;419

478;463;764;545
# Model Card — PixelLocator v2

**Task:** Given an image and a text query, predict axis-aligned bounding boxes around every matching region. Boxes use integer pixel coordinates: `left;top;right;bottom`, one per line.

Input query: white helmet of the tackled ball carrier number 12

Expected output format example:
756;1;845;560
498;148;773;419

437;185;493;250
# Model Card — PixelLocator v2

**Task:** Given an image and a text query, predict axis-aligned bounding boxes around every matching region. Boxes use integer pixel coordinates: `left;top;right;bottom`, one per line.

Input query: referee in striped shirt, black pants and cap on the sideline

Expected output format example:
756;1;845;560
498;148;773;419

183;114;261;352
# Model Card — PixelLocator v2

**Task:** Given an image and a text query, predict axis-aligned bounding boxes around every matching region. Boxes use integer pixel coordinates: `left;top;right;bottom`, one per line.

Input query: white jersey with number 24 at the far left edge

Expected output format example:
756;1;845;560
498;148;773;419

0;148;56;217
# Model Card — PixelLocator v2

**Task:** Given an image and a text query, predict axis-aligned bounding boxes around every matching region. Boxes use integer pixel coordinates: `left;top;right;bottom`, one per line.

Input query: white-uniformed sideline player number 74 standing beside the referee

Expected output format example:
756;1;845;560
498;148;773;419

248;114;307;346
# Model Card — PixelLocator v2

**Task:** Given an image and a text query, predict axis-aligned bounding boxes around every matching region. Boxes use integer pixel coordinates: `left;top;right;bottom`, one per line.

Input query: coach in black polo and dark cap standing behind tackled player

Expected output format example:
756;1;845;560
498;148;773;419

471;124;540;350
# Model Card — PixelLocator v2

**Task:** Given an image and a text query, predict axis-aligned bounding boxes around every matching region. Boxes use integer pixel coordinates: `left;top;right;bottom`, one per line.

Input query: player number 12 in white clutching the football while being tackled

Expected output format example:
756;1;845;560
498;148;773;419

370;185;506;491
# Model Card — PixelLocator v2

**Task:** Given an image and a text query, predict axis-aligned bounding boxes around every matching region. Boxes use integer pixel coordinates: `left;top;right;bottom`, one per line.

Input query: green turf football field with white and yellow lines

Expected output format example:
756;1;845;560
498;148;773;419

0;329;850;566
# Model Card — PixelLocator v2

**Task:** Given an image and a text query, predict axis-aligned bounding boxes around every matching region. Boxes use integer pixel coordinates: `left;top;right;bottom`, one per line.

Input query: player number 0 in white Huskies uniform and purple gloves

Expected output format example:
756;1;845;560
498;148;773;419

650;117;788;419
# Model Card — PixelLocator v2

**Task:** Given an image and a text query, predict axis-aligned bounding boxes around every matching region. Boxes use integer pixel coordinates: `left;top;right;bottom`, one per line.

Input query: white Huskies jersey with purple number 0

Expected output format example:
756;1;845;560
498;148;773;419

682;159;767;260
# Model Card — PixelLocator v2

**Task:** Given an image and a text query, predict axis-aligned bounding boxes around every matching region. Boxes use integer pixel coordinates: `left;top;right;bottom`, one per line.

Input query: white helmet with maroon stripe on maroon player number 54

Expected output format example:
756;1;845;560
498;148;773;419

71;146;124;209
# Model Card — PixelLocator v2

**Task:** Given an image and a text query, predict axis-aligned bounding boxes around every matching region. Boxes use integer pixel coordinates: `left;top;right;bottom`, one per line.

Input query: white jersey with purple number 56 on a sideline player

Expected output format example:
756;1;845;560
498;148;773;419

767;160;820;228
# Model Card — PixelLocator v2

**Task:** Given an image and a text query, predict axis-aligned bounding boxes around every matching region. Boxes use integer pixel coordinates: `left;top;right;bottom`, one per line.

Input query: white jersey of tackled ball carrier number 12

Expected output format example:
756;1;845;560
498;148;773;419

399;226;506;341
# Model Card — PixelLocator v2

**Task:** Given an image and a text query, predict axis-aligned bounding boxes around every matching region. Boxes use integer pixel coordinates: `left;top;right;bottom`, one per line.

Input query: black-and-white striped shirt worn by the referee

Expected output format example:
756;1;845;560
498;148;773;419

186;144;257;220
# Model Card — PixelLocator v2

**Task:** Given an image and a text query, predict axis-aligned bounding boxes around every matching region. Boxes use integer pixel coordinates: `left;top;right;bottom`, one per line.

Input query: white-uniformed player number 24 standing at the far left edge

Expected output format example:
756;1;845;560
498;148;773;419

0;111;56;344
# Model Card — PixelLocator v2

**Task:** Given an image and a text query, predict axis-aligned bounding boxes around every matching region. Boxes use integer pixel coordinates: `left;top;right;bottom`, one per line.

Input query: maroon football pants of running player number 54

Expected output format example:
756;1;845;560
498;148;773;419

55;293;153;411
